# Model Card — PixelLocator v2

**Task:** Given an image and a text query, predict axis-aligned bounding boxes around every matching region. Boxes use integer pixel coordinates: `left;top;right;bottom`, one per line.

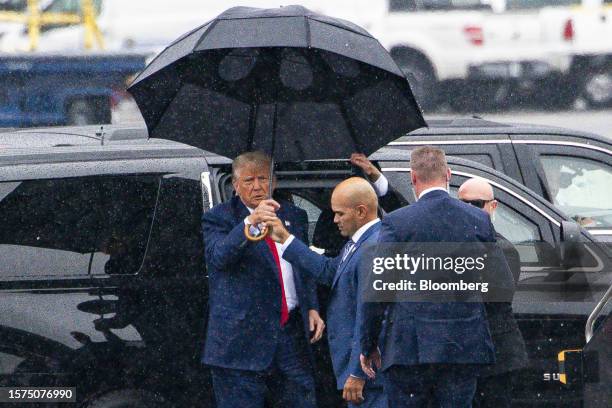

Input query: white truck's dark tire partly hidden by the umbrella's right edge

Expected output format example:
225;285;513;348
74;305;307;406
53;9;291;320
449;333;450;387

395;54;439;111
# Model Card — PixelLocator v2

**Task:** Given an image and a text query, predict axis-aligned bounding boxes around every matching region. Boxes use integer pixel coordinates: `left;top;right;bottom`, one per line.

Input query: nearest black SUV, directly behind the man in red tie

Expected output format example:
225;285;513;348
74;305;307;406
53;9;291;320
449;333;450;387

0;127;612;408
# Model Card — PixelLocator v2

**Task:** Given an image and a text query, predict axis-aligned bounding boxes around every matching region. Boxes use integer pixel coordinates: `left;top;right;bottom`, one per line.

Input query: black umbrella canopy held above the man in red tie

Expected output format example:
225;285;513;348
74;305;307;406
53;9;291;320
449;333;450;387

128;6;426;161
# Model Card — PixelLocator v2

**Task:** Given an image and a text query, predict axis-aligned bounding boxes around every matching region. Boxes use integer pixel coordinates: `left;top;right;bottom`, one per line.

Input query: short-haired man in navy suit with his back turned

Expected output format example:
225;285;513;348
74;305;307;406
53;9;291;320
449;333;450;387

361;147;512;408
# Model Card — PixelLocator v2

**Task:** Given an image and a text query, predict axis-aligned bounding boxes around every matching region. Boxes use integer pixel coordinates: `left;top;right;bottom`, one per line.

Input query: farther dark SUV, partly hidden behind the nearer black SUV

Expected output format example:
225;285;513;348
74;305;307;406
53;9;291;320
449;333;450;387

389;118;612;242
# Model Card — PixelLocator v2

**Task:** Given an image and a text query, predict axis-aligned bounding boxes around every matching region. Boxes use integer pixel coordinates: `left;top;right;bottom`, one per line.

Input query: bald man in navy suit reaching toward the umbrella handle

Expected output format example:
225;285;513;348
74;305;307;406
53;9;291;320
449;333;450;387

269;178;387;408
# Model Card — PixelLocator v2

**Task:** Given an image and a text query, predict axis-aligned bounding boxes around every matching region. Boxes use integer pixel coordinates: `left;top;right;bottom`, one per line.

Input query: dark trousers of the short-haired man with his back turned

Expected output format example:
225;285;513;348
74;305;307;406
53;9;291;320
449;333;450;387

384;364;478;408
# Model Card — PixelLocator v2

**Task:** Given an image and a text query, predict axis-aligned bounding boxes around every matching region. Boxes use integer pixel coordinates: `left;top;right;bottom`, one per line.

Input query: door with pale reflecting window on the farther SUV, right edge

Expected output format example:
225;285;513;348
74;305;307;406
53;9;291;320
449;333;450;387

514;140;612;242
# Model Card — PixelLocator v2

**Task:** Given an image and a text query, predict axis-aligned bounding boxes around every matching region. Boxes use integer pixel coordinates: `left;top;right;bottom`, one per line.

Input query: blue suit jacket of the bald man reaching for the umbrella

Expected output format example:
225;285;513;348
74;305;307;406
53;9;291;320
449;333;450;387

283;223;380;389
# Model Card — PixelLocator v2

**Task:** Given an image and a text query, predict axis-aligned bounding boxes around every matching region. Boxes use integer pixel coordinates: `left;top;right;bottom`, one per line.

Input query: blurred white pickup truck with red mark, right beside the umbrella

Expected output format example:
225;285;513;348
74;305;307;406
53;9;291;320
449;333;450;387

369;0;571;110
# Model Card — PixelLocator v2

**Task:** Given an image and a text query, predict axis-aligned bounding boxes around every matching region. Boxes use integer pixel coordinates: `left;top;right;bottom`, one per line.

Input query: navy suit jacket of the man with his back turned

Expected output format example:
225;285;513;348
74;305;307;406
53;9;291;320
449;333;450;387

361;190;512;370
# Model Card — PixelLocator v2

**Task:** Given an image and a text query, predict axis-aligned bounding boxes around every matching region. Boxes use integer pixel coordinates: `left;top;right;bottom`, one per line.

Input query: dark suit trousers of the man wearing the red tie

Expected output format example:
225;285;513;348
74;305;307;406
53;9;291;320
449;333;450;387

211;310;316;408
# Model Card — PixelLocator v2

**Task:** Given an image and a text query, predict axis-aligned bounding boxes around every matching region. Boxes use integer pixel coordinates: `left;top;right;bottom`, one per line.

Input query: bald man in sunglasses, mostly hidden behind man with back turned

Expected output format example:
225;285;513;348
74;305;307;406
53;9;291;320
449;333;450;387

458;178;527;408
